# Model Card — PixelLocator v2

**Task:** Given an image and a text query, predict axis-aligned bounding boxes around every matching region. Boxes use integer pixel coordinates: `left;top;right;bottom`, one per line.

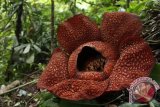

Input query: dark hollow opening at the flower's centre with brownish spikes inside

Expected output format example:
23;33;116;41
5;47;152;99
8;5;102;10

77;46;106;72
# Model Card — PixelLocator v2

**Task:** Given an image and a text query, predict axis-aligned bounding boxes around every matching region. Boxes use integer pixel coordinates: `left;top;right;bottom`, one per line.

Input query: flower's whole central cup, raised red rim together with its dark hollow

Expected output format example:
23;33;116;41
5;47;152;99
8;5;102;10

68;41;116;81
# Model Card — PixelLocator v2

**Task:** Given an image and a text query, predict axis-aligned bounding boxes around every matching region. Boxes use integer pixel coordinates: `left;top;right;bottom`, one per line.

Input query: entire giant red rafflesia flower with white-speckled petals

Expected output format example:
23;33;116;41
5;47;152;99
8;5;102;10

37;12;154;100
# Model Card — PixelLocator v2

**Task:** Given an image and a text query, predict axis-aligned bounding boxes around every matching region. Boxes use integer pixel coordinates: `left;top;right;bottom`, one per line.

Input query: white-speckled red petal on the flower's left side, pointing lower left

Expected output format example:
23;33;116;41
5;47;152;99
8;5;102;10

37;48;68;89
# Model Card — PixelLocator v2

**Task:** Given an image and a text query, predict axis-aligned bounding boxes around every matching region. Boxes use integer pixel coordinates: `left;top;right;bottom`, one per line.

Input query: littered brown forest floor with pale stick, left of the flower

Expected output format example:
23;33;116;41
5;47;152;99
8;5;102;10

0;72;40;107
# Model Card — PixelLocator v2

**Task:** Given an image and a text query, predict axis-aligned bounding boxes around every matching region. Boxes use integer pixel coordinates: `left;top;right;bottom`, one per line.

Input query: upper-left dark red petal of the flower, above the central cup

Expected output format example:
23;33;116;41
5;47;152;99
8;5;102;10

58;14;100;53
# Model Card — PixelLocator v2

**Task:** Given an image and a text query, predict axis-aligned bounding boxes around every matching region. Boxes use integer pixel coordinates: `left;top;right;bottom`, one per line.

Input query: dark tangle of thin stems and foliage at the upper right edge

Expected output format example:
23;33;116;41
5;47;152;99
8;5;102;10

142;1;160;62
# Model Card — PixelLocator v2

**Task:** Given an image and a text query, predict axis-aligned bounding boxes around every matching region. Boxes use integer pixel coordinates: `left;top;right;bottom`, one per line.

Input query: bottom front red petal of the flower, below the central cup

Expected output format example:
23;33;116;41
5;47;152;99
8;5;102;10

49;79;108;100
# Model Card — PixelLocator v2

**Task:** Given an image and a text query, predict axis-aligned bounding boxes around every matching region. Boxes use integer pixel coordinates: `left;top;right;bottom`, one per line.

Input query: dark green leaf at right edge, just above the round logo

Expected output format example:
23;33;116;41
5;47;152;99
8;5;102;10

150;63;160;83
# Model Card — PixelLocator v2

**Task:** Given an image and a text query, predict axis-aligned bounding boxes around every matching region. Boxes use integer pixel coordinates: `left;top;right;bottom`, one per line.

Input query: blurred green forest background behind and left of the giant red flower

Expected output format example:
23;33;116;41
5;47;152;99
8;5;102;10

0;0;160;107
